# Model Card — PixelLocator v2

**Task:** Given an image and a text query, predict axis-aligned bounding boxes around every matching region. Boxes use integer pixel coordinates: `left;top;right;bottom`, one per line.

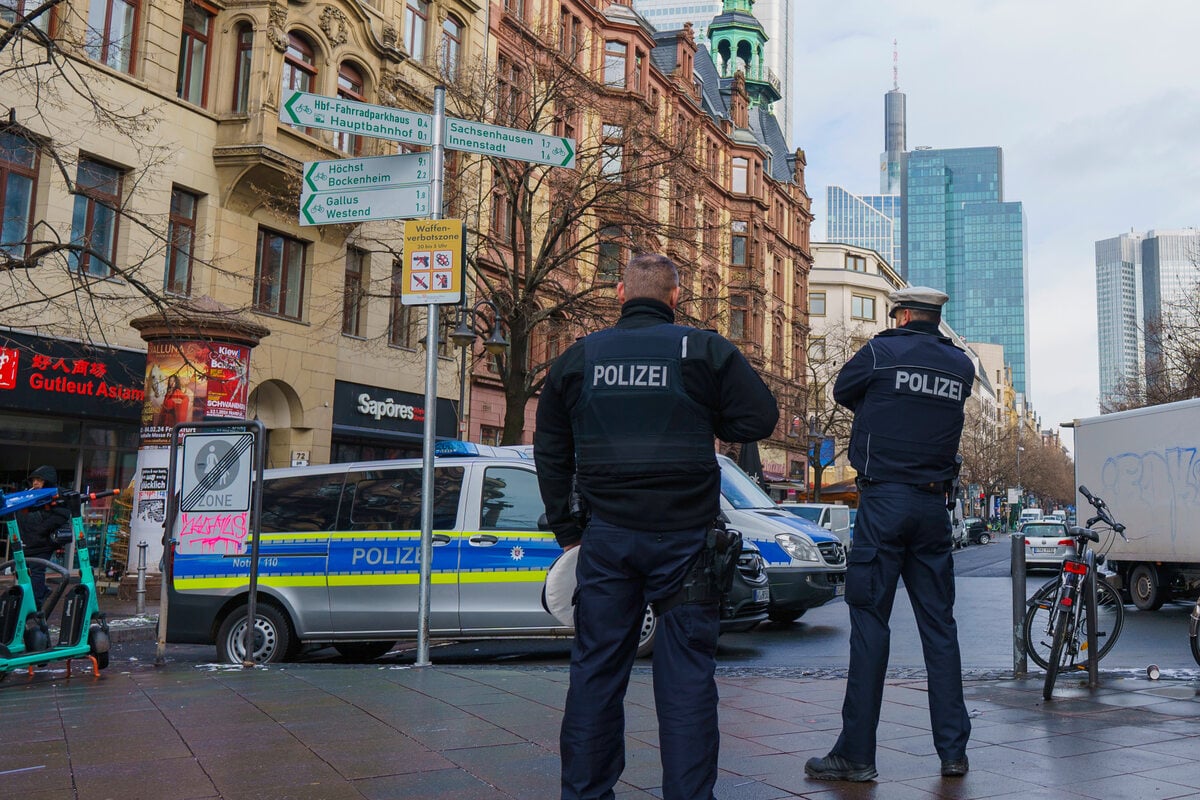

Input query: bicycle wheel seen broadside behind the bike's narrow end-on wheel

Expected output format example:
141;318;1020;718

1022;576;1124;672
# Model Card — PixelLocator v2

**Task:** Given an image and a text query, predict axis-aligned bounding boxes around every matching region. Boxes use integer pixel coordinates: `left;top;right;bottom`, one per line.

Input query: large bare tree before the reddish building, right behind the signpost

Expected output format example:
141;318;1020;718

427;23;707;444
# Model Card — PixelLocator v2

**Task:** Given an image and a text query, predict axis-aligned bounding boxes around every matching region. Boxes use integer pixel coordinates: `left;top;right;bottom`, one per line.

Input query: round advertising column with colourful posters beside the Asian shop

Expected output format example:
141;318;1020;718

126;297;270;575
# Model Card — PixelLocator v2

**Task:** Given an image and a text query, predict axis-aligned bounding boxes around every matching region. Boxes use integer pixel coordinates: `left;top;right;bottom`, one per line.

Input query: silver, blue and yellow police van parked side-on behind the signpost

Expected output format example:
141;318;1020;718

166;441;767;663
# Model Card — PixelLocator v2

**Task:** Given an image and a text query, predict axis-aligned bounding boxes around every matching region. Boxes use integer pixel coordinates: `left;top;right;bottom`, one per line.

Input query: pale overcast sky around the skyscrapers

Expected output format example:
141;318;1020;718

790;0;1200;446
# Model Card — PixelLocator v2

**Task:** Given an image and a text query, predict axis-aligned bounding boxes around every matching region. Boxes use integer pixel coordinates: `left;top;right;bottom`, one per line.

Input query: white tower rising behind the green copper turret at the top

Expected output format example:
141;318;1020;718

632;0;798;143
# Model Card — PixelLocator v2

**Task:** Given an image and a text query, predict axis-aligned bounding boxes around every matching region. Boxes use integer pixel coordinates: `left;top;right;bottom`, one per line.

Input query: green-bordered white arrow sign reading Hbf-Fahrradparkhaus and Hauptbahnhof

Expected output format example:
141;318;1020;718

280;91;433;145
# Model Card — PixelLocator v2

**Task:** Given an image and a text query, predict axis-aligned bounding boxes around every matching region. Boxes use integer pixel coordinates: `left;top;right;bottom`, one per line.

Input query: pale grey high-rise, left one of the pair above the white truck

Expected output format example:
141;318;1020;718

1096;233;1146;407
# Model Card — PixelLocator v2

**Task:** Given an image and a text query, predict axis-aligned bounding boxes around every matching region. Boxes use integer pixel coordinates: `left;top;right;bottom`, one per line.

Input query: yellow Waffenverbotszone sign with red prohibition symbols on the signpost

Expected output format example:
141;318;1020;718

400;219;467;306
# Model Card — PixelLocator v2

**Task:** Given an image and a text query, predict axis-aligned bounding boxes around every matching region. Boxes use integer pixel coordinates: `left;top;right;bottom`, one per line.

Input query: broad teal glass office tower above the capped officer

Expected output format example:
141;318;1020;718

900;148;1030;396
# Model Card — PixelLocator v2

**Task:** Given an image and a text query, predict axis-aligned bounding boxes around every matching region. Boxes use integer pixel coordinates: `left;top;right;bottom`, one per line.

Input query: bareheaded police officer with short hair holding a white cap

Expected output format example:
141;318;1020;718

534;254;779;800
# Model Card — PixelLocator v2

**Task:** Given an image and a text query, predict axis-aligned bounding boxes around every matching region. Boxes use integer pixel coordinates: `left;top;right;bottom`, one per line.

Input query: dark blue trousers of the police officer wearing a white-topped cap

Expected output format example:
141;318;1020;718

830;483;971;764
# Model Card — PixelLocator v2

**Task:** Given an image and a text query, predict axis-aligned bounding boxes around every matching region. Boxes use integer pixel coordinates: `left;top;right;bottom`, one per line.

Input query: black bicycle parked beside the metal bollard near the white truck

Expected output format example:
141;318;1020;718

1022;486;1123;700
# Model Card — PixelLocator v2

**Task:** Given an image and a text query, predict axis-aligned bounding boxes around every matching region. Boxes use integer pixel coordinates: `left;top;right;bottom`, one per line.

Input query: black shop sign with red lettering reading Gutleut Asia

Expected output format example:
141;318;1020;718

0;332;145;420
